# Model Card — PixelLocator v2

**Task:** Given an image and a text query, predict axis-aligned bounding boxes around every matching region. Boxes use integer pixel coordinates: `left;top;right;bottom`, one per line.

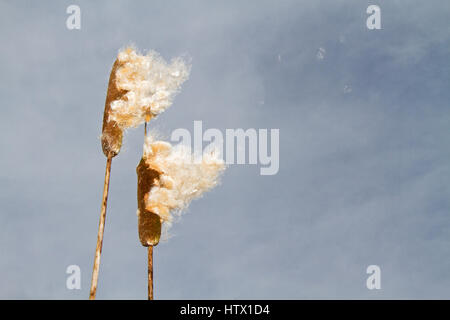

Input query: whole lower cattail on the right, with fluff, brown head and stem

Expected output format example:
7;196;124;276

136;136;225;300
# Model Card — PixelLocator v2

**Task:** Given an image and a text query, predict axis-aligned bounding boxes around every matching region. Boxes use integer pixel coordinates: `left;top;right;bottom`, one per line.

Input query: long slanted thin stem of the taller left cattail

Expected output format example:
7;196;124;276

89;155;112;300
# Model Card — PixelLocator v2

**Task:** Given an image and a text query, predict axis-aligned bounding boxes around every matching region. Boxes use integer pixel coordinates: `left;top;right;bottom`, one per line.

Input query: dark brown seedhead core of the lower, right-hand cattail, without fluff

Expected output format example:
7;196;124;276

136;158;161;247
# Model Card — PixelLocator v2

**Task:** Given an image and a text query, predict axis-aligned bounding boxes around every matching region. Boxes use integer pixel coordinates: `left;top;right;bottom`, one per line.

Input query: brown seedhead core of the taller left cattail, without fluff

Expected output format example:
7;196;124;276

102;60;127;157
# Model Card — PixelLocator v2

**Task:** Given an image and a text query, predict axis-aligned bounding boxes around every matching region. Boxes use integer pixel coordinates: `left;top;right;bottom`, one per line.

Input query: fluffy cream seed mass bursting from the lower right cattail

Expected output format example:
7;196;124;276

144;137;225;225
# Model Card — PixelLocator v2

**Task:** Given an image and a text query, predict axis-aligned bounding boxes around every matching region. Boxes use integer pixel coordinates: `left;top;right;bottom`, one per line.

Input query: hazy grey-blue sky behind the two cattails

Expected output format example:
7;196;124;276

0;0;450;299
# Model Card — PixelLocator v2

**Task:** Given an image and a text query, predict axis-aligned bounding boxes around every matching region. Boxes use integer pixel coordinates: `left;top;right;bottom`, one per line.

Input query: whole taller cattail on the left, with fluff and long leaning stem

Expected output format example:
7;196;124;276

89;47;190;299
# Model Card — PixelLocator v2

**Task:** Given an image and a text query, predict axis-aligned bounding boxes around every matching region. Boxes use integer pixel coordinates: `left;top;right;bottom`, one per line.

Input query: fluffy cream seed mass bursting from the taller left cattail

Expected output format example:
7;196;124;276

109;47;190;130
